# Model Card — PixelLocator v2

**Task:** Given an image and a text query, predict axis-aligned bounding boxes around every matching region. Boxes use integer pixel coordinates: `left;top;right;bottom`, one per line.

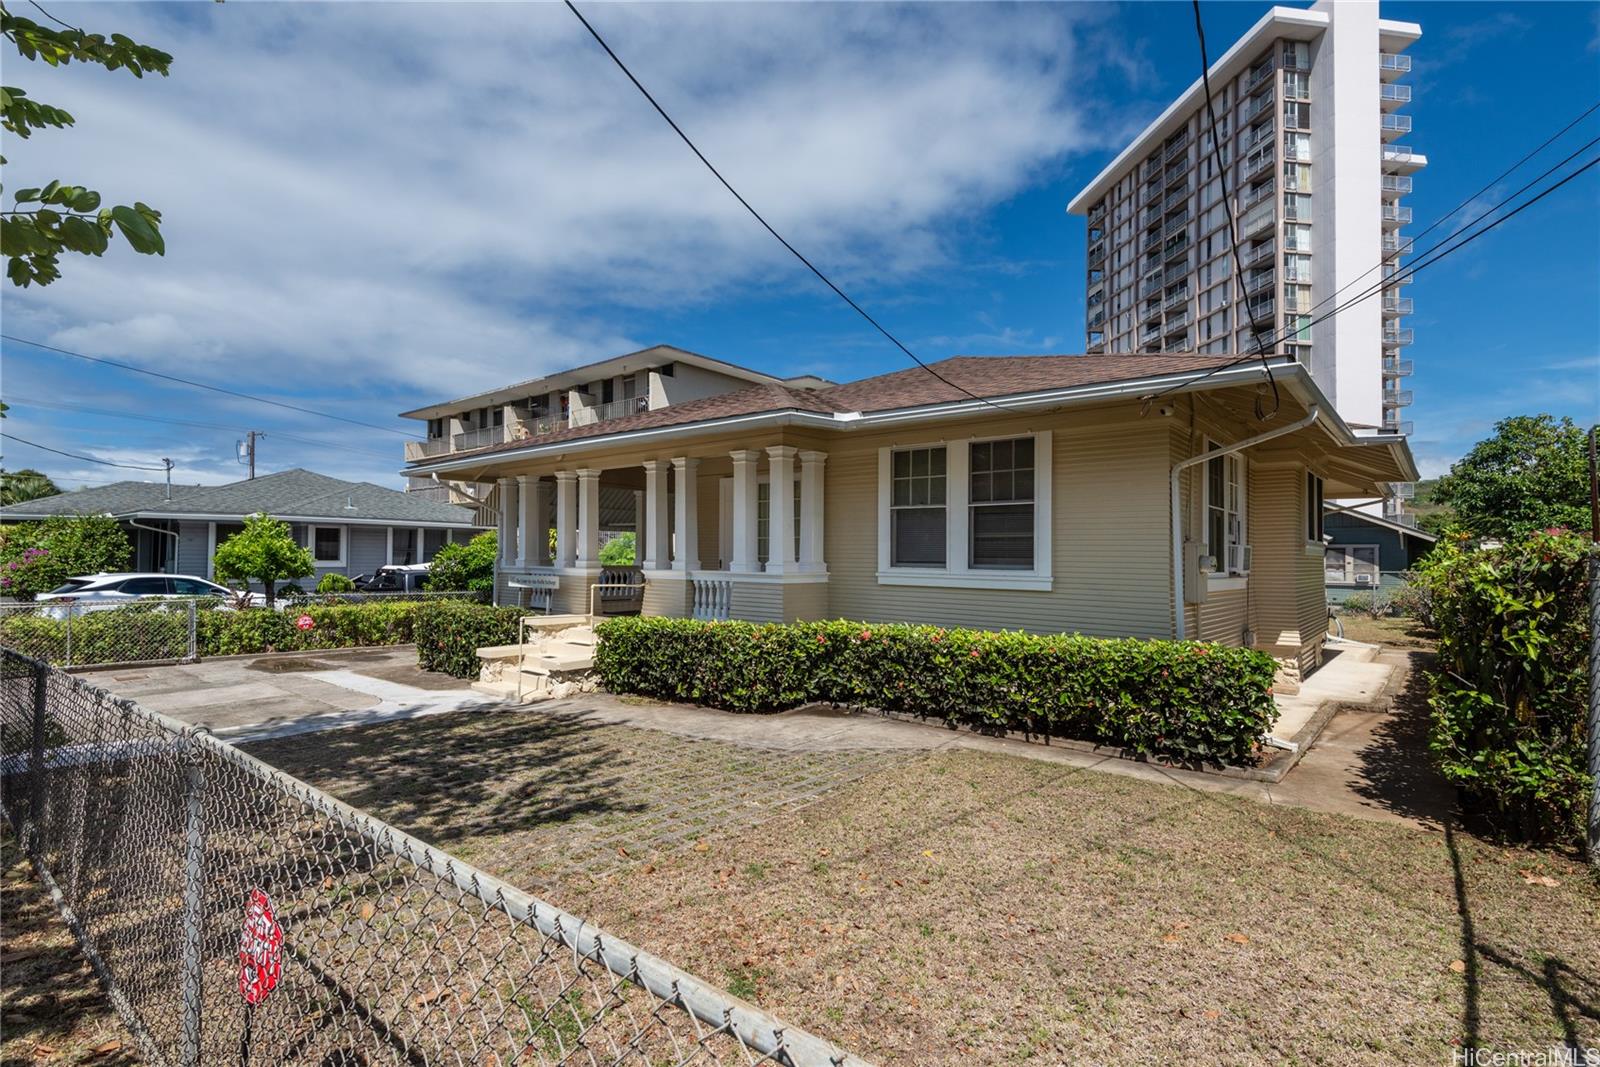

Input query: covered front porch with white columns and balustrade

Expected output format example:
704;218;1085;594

494;443;829;622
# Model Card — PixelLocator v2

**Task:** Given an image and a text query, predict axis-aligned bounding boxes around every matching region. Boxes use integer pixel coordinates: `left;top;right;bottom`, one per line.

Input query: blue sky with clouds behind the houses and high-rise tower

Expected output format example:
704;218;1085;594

0;3;1600;486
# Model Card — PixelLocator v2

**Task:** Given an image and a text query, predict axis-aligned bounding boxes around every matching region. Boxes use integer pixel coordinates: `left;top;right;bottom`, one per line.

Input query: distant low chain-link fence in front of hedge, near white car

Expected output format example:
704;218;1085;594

0;597;206;667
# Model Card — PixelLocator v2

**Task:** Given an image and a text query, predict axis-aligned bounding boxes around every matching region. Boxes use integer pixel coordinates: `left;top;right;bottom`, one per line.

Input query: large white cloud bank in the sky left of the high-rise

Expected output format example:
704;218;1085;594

5;3;1120;396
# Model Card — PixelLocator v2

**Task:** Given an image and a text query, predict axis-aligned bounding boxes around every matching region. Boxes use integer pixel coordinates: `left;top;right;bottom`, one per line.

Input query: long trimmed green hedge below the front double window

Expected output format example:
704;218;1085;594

595;617;1277;765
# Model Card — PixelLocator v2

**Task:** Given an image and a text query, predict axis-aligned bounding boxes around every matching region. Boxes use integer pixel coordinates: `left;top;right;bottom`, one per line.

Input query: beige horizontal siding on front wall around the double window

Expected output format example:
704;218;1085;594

824;416;1171;637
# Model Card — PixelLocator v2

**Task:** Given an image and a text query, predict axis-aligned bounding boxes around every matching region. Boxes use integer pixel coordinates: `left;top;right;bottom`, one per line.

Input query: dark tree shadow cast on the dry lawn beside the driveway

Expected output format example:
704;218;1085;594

243;712;646;849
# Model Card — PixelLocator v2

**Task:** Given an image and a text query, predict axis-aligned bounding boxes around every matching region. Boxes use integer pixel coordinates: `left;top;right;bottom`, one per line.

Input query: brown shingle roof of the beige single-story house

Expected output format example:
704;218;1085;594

435;352;1238;459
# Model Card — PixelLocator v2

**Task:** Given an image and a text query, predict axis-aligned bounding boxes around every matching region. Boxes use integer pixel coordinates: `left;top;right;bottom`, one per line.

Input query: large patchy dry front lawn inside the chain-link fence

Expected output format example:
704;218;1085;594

246;715;1600;1065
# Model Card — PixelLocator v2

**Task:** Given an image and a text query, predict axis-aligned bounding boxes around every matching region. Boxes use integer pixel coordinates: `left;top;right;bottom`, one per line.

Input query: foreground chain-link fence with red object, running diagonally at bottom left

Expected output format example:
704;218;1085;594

0;649;864;1067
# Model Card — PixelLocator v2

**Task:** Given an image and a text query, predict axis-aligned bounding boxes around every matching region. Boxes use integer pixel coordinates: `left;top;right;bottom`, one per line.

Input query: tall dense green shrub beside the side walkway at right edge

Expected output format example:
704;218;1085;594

1418;531;1592;840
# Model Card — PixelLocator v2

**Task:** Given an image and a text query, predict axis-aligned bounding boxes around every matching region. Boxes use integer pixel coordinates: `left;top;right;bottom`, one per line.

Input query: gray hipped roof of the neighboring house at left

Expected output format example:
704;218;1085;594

0;467;477;526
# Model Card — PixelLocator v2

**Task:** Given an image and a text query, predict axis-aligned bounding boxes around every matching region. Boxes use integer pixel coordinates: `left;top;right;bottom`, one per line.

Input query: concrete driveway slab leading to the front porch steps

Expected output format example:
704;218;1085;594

85;645;494;741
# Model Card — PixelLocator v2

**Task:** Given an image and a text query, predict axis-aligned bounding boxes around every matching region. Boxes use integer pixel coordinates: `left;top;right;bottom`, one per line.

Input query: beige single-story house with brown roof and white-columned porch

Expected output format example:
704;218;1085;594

396;347;1418;685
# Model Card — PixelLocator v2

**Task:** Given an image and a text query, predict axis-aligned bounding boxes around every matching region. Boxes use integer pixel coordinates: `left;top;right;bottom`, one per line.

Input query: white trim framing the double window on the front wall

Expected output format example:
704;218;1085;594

877;430;1054;592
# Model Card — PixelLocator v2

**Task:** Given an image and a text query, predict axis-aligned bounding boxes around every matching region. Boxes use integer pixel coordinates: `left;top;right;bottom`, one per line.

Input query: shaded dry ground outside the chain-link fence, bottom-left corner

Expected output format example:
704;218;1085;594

0;833;142;1067
